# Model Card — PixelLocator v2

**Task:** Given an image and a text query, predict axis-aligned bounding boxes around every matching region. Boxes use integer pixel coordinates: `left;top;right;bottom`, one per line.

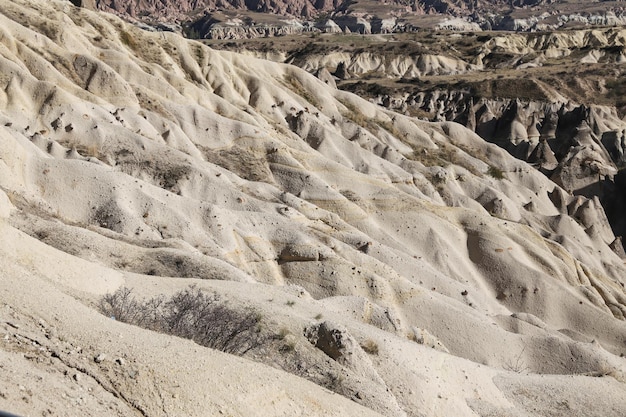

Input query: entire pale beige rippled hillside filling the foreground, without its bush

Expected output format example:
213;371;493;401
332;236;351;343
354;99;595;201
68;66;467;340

0;0;626;416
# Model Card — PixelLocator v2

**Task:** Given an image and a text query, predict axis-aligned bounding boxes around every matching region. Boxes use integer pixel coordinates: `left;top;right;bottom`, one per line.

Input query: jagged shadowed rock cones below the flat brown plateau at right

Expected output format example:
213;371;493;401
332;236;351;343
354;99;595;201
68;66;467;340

376;89;626;195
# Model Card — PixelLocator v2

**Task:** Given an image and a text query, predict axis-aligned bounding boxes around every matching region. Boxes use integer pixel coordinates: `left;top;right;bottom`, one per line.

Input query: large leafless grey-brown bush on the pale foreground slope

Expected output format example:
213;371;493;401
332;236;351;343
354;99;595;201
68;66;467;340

100;286;267;355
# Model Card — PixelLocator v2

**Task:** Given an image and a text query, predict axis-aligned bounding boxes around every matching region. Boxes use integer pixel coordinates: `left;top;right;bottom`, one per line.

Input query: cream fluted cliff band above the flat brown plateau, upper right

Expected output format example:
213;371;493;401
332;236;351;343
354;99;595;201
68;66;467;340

252;27;626;77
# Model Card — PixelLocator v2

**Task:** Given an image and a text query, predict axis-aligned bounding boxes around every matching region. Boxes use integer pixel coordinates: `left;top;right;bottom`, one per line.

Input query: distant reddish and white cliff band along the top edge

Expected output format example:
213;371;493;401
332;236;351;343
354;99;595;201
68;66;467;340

89;0;626;39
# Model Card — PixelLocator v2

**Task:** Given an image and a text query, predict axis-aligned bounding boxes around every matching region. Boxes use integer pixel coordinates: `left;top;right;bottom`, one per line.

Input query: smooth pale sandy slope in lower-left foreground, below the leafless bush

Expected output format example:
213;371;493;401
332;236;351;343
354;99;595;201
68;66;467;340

0;244;380;417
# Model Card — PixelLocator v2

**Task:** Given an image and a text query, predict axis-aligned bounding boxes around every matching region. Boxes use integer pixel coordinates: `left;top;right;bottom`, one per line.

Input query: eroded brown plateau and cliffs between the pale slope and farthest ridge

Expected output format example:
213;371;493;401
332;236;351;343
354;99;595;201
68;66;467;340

212;28;626;236
